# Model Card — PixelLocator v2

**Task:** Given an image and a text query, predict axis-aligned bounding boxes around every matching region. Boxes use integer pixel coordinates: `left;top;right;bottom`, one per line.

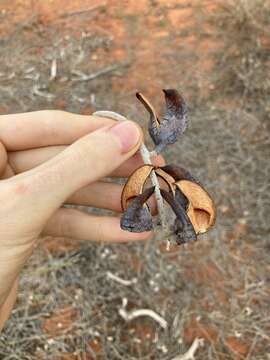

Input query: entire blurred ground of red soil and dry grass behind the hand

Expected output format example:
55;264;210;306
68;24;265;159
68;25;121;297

0;0;270;360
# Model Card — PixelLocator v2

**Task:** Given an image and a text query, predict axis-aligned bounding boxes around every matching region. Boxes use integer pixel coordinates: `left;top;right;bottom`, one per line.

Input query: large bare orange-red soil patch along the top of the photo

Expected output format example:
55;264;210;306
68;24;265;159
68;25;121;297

0;0;222;105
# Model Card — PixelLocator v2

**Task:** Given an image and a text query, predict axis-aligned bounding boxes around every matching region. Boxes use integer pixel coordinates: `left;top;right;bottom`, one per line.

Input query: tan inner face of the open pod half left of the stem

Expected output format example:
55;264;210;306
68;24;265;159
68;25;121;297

121;165;154;211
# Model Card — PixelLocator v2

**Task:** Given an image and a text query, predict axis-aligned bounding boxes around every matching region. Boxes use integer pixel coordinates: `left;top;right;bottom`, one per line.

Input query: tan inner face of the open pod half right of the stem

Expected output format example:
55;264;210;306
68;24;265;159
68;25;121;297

175;180;216;234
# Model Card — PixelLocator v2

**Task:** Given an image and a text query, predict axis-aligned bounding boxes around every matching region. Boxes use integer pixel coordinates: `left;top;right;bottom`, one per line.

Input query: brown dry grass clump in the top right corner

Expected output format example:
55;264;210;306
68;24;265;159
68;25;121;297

209;0;270;120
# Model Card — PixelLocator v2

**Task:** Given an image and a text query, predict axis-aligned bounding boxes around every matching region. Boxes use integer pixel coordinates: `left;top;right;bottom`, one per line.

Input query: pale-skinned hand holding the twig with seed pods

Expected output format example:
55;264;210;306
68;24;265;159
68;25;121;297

0;110;163;330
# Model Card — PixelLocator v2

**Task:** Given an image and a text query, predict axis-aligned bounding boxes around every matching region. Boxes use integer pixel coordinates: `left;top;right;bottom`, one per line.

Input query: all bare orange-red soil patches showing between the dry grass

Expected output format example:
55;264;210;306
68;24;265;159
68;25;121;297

0;0;268;360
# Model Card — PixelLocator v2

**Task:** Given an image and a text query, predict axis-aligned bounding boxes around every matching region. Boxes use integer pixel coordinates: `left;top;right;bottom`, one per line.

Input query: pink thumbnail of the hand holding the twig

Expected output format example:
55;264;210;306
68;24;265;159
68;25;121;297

109;121;141;153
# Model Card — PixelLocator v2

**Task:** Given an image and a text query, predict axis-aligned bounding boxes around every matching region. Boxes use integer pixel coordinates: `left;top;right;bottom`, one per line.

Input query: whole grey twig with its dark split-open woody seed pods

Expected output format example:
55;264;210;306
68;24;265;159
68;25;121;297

93;89;216;245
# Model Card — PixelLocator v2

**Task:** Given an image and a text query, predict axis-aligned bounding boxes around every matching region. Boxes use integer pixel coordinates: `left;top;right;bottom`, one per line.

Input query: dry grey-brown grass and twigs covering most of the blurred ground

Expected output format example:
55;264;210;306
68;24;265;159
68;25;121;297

0;0;270;360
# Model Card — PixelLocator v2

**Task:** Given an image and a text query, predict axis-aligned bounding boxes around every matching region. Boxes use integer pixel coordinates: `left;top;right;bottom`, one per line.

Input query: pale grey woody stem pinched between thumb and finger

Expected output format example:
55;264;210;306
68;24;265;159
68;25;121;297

93;111;166;228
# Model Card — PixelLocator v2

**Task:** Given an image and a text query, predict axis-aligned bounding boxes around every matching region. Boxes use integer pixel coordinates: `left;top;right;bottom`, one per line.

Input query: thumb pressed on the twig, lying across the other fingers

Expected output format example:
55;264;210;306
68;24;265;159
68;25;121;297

10;121;143;217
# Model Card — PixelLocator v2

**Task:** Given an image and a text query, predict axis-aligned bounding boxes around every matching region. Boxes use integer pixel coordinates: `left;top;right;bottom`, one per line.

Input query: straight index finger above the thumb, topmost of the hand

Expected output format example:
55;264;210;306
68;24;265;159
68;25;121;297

0;110;115;151
